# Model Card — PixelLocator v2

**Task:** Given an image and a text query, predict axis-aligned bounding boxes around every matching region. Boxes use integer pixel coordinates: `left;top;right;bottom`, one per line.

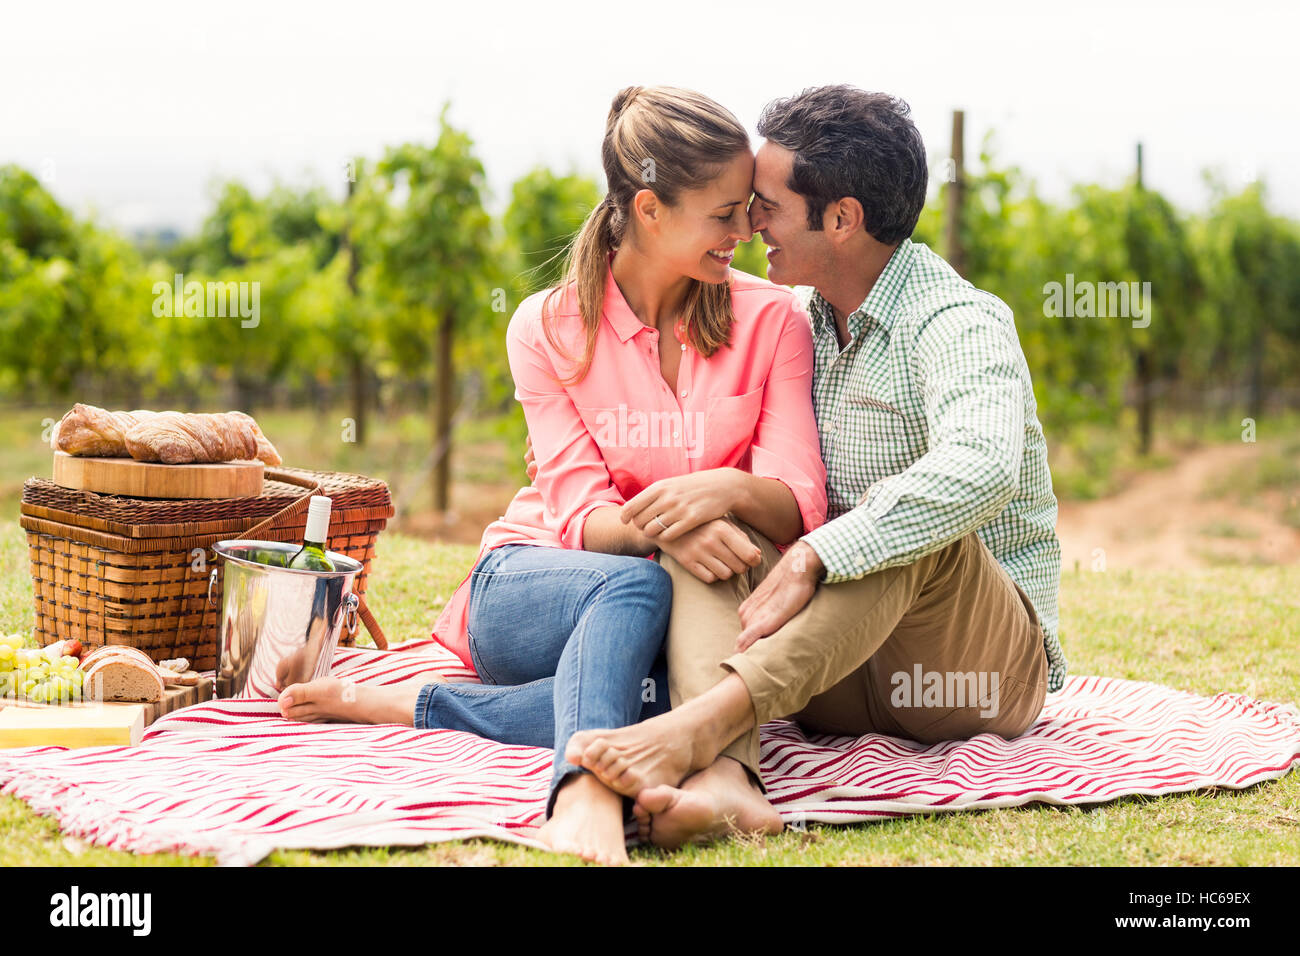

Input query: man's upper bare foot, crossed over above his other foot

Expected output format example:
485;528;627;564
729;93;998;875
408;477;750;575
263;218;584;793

564;711;699;796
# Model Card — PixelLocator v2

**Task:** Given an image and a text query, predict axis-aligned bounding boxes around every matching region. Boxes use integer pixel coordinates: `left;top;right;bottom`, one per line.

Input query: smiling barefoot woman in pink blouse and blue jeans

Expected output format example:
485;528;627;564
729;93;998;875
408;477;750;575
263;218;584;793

281;87;826;862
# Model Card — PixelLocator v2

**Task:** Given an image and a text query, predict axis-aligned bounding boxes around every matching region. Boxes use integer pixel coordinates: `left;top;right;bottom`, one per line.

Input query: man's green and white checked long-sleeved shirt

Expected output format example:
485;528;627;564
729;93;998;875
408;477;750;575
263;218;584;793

798;239;1067;691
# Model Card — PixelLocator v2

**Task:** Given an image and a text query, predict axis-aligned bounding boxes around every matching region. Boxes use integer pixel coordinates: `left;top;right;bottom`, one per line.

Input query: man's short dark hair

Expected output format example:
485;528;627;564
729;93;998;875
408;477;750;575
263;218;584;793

758;86;928;246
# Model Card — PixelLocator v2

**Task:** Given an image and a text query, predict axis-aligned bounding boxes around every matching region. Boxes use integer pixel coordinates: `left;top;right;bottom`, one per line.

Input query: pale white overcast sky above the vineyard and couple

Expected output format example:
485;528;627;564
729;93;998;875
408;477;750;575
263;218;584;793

0;0;1300;229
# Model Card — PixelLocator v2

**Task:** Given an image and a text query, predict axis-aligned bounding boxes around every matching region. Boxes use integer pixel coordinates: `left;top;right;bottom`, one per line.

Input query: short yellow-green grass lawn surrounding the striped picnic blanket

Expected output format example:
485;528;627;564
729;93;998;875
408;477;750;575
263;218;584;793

0;520;1300;866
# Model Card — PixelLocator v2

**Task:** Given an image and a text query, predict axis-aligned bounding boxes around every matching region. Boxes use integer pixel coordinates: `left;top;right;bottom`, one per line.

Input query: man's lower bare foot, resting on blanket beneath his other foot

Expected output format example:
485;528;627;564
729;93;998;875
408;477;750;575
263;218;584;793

632;757;783;849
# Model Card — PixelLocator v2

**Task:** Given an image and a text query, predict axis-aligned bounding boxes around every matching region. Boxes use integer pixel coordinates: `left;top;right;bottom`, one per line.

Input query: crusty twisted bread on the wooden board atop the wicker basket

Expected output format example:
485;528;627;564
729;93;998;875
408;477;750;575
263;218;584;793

51;403;282;466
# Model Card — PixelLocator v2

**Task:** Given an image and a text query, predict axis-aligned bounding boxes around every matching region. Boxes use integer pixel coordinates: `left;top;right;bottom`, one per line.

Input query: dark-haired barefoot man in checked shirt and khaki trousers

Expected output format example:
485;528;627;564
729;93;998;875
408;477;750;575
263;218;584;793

566;86;1066;847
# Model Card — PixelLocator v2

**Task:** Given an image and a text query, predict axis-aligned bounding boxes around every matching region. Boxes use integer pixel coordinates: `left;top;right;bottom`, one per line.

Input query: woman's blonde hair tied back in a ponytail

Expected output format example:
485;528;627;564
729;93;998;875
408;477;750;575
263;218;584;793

542;86;749;385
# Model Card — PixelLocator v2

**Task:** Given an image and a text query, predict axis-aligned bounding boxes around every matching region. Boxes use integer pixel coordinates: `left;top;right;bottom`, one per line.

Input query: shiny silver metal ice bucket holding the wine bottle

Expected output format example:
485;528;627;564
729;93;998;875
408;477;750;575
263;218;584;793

208;540;361;697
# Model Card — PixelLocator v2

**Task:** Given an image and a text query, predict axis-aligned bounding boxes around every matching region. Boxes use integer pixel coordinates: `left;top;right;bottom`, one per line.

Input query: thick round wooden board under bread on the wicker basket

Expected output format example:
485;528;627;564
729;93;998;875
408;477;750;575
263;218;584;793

53;451;267;498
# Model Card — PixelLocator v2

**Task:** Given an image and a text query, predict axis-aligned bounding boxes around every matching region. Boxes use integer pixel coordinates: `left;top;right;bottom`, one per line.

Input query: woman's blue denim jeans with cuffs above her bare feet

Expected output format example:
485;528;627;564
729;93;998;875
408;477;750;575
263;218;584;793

415;545;672;818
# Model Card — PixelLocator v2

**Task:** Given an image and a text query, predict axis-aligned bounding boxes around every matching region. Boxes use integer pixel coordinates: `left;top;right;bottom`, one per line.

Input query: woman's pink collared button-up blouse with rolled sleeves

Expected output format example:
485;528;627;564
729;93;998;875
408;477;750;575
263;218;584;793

433;260;827;667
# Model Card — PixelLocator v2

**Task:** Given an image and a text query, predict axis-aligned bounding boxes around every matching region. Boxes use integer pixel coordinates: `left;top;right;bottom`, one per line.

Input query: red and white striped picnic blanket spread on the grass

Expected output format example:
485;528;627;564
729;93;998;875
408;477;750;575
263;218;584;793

0;640;1300;865
